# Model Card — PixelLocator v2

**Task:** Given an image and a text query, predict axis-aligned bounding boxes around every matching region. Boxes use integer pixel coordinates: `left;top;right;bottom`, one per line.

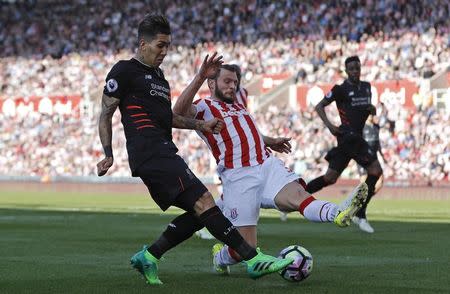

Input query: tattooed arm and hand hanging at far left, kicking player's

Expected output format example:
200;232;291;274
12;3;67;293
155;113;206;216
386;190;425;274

97;94;120;177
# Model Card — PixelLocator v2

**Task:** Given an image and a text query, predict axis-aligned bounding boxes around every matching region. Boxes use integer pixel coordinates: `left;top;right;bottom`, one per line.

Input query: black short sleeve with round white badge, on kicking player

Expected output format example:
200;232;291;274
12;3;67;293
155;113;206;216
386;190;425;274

103;61;129;99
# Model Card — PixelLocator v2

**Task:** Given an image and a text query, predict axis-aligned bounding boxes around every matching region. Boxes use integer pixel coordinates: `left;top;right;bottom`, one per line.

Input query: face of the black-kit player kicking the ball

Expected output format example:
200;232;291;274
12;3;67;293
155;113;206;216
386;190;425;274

139;34;172;67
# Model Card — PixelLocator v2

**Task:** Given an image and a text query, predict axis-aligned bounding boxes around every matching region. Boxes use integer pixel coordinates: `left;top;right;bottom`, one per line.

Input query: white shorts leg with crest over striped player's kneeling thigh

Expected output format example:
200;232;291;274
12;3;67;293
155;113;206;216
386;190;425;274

221;166;261;227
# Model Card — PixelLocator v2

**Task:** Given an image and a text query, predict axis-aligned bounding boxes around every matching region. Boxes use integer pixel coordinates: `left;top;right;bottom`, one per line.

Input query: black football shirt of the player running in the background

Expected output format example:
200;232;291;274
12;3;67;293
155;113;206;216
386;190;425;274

325;80;372;135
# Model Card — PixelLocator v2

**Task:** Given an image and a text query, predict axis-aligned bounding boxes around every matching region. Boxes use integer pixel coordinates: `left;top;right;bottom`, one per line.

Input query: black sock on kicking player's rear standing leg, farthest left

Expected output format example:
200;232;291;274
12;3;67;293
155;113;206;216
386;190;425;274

147;212;203;259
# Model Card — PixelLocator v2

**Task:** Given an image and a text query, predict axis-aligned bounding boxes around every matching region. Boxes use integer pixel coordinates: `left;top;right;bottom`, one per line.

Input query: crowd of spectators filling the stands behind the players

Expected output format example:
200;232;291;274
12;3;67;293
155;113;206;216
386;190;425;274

0;0;450;182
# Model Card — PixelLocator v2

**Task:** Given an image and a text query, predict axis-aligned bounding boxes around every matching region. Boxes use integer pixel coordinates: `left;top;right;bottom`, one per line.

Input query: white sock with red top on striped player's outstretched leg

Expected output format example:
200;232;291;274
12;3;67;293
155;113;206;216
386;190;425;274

299;196;338;222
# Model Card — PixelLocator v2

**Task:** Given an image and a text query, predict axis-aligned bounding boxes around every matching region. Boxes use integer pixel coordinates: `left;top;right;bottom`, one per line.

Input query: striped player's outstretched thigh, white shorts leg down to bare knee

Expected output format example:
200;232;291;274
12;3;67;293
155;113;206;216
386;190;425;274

261;156;301;211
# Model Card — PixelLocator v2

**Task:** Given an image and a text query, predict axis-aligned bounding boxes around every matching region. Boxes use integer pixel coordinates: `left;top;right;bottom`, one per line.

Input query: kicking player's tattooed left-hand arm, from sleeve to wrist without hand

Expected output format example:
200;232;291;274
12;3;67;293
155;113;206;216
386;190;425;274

98;95;120;155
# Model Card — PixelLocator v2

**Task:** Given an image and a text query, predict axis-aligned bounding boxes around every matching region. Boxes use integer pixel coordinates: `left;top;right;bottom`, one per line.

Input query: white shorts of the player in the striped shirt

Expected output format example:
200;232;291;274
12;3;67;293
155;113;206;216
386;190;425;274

220;156;299;227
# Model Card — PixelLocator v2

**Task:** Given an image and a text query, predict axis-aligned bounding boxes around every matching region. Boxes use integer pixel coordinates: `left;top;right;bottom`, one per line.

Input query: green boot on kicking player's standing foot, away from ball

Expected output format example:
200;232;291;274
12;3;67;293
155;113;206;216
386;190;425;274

130;246;162;285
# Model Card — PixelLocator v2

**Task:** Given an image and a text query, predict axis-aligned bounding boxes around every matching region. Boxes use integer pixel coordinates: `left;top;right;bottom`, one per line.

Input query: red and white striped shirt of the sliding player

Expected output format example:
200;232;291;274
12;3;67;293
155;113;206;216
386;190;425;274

194;98;269;168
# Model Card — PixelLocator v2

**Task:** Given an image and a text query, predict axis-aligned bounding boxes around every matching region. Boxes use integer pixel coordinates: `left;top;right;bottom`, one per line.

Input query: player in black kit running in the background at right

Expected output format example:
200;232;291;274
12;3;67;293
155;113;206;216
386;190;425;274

306;56;383;233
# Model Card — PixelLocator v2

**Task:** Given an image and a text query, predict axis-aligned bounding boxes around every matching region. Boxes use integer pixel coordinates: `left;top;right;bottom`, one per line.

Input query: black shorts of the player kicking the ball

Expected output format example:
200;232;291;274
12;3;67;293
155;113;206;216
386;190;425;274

136;155;208;212
